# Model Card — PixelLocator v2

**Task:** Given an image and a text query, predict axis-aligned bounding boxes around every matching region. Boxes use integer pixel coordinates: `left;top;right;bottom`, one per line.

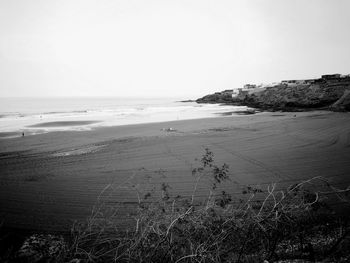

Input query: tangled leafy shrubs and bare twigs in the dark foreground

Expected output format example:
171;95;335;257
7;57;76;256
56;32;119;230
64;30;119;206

2;149;350;263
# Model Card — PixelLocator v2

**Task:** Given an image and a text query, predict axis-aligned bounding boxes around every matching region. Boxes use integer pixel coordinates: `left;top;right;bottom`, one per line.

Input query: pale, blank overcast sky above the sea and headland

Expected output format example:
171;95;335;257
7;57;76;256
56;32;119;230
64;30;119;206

0;0;350;99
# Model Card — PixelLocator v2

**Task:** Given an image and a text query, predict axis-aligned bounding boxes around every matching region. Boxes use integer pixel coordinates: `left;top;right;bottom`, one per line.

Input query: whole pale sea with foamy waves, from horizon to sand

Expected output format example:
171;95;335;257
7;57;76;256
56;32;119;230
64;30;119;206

0;98;250;138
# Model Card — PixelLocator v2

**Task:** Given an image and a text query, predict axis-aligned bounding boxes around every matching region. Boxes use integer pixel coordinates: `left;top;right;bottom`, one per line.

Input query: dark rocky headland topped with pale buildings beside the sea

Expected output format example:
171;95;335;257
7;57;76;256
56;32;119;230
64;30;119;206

196;74;350;111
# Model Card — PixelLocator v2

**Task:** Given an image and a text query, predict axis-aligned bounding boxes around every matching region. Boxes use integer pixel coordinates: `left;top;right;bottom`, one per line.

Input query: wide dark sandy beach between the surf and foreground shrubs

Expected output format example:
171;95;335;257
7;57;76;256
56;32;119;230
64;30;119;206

0;112;350;230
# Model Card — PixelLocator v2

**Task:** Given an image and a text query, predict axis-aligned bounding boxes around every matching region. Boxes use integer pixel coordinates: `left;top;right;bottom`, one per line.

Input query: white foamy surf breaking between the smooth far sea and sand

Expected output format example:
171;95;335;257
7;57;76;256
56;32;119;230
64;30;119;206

0;100;252;137
